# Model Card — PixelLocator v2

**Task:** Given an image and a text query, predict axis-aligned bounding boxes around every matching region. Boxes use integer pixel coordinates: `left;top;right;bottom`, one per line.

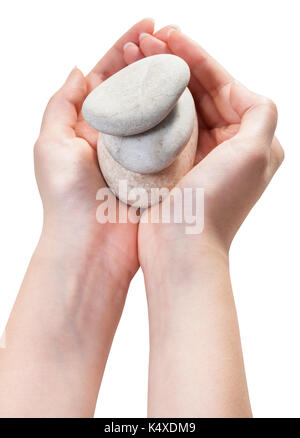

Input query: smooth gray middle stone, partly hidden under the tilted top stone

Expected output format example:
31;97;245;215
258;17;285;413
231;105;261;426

102;88;195;174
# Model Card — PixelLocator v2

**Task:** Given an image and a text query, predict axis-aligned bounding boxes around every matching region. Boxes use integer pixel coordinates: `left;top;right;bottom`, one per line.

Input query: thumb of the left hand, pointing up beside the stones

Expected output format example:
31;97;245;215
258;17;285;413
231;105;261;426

40;68;87;139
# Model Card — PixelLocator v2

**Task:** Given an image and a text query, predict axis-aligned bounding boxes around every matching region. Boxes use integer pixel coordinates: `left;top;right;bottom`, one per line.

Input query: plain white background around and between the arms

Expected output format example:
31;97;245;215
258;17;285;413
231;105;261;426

0;0;300;417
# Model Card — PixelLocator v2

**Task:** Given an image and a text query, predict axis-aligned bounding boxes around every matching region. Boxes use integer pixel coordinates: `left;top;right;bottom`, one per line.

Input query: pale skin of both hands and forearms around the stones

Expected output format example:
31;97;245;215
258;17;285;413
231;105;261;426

0;19;283;417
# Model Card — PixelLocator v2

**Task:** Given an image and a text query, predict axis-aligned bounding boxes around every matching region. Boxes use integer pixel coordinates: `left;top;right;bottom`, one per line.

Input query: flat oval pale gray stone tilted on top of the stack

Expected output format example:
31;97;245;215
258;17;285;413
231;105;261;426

82;54;190;136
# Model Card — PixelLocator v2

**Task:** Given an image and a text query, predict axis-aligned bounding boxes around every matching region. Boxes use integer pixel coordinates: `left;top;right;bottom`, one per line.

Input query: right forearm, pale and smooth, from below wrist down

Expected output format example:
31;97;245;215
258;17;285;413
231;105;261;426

146;241;251;417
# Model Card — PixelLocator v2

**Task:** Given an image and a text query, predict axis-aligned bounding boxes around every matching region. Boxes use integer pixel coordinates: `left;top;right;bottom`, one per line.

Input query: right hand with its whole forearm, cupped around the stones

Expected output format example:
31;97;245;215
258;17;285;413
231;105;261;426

124;27;283;417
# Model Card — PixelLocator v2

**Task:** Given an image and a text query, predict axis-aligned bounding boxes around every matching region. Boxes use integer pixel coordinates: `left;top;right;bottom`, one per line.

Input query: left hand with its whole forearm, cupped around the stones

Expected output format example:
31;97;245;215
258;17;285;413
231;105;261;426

0;20;158;417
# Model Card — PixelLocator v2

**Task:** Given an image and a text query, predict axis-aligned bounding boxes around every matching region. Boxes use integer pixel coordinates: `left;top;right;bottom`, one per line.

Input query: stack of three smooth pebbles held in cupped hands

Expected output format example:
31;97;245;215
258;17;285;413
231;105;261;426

82;55;198;208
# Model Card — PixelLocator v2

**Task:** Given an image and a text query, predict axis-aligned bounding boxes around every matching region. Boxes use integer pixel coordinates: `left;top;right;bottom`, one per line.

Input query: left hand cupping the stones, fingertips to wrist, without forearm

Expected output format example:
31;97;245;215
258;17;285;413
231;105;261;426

35;19;153;288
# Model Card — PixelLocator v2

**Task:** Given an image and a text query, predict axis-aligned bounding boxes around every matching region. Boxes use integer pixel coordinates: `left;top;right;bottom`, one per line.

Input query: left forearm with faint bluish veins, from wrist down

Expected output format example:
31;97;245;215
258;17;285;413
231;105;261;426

0;222;130;417
